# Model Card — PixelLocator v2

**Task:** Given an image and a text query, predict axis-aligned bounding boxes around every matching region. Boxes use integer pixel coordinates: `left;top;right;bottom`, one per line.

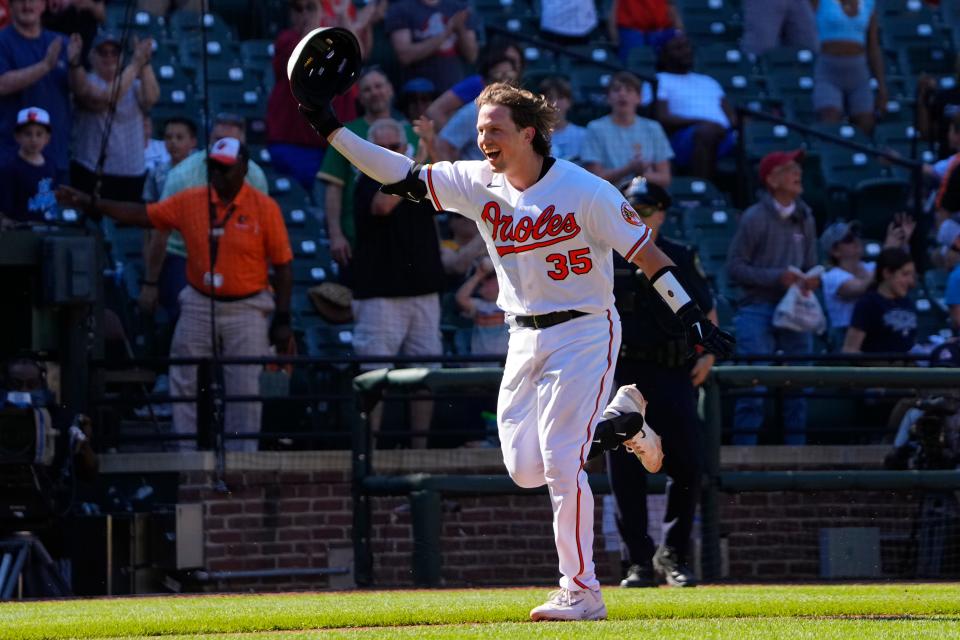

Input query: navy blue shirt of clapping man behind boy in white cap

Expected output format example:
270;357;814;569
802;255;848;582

0;25;70;175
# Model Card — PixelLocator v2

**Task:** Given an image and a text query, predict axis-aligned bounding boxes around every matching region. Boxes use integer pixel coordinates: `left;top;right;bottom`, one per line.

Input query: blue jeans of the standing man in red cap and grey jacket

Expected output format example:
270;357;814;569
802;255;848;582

733;303;813;445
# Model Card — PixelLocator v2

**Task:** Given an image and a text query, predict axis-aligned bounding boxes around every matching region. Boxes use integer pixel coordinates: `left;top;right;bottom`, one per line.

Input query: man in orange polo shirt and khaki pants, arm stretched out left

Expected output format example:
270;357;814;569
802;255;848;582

57;138;293;451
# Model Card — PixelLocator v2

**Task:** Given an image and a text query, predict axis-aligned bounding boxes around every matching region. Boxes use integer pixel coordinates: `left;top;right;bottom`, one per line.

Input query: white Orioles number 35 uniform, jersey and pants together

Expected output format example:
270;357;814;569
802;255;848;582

420;160;651;590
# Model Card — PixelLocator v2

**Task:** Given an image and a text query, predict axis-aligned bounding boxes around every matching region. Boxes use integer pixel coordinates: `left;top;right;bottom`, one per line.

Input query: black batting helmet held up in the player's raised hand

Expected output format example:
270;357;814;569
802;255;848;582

287;27;361;109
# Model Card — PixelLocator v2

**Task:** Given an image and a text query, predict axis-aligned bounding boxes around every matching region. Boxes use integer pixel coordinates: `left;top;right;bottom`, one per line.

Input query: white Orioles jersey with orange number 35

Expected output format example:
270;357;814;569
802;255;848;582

420;160;650;315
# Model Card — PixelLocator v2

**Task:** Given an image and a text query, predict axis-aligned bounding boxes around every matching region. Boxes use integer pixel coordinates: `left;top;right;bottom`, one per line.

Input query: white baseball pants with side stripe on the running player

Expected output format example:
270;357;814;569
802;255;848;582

497;310;620;590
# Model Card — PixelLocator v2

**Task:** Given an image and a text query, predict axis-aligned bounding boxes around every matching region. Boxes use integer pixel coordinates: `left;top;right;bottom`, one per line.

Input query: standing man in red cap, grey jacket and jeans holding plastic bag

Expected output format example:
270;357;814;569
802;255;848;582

727;150;820;445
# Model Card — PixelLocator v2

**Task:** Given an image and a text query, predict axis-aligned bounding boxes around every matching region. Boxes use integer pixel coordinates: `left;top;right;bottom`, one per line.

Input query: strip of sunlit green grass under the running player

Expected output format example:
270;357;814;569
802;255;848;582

0;583;960;640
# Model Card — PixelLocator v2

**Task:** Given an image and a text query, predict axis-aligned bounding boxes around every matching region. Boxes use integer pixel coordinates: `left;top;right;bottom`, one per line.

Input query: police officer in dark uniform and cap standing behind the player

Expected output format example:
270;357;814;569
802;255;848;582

607;178;717;587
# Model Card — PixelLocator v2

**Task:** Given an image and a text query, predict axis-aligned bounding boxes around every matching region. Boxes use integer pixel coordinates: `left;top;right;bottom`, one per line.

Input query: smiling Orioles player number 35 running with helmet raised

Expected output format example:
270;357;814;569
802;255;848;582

287;28;733;620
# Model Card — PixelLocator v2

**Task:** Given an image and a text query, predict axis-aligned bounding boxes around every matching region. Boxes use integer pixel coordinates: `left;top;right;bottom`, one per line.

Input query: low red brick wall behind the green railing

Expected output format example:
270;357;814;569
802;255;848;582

101;447;948;590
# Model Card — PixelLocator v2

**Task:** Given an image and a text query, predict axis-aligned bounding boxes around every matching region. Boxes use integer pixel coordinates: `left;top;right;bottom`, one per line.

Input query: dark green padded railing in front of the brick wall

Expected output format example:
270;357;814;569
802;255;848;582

352;366;960;586
